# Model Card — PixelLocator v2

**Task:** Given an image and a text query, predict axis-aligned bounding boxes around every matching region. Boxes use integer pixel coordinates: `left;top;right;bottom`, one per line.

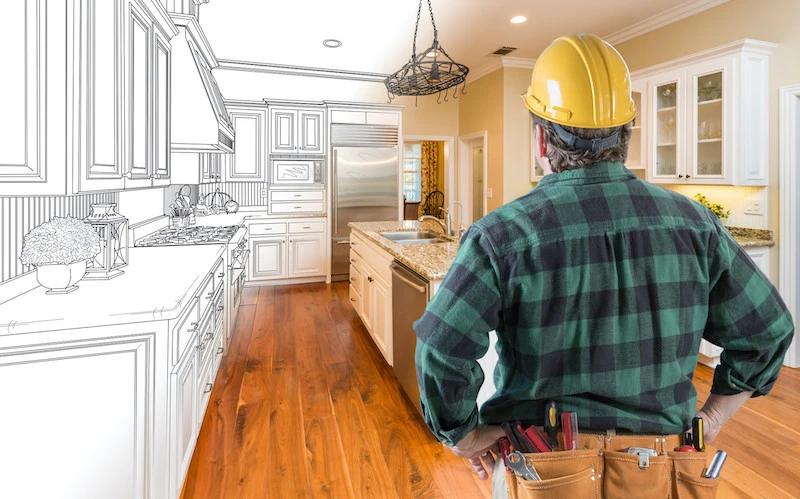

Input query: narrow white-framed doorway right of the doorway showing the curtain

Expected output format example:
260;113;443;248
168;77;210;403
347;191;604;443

456;130;489;225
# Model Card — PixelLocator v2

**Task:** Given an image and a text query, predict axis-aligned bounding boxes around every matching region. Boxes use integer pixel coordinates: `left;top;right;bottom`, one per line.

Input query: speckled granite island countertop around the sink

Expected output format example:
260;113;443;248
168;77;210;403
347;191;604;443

349;220;458;281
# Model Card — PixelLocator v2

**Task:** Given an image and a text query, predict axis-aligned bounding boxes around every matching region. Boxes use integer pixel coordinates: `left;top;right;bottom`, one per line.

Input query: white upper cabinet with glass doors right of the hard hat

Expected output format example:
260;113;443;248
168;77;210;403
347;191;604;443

628;40;777;185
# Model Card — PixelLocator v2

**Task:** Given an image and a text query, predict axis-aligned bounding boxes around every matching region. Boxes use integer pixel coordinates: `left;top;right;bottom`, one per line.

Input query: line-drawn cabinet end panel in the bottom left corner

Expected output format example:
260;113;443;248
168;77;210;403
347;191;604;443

0;324;158;497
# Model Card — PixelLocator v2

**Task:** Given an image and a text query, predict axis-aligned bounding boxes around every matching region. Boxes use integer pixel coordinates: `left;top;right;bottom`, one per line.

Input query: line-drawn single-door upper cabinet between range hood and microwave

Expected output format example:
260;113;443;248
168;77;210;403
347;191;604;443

225;101;267;182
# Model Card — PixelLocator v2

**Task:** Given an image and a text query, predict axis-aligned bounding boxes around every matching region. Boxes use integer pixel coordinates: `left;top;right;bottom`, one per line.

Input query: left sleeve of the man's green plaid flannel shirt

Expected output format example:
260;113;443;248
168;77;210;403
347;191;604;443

414;226;502;446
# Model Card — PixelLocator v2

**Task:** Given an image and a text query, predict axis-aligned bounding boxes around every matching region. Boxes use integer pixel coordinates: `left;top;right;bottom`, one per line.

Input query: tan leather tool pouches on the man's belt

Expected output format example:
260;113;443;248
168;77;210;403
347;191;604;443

506;434;720;499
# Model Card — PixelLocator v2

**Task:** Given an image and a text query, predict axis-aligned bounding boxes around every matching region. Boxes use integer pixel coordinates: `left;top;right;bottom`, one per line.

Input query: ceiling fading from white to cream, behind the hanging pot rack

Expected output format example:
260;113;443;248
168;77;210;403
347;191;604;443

200;0;720;78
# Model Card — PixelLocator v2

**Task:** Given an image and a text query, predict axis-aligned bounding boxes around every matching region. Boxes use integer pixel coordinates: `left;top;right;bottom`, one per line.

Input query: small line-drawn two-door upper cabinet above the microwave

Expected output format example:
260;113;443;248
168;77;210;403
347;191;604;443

269;105;325;154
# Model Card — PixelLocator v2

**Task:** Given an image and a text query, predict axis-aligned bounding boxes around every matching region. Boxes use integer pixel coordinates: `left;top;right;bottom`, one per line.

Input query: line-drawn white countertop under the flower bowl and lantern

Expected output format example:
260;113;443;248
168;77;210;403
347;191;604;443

0;244;225;337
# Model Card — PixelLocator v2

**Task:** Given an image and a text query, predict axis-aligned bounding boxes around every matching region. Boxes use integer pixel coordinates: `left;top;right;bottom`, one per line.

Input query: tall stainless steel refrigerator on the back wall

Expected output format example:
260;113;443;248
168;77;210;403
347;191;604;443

331;125;400;281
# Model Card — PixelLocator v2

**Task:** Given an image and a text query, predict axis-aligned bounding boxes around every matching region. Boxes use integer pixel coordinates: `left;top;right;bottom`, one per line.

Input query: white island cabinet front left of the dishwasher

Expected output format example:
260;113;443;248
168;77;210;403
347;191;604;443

350;233;394;365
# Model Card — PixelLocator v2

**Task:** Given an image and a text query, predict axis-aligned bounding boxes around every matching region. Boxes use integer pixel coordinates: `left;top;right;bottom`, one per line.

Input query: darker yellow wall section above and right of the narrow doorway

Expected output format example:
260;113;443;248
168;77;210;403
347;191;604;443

458;69;505;211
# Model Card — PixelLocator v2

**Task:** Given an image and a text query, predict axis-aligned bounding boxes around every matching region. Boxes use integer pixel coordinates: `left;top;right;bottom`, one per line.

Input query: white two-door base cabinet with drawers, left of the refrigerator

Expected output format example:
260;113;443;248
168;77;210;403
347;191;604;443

247;217;328;282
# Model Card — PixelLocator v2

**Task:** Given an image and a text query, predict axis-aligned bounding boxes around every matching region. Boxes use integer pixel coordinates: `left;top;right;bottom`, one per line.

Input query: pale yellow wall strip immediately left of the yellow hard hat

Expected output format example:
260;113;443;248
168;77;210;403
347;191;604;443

503;68;535;203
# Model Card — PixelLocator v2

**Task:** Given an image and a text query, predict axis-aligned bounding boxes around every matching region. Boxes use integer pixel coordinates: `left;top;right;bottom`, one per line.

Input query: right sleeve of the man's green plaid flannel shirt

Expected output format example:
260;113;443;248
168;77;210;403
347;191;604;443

703;227;794;397
